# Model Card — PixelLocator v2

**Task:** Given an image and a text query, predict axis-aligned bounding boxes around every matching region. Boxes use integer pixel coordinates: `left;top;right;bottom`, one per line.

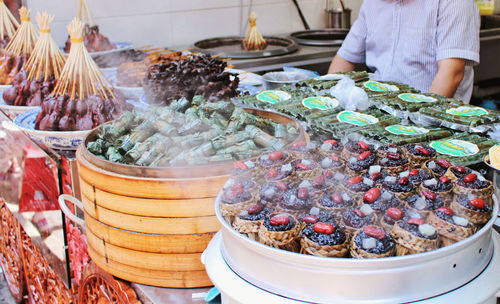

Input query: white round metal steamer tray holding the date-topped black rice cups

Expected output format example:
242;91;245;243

215;194;498;303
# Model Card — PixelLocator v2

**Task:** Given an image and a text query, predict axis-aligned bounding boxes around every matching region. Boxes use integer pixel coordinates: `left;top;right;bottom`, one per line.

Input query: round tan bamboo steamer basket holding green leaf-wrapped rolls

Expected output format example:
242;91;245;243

76;109;309;288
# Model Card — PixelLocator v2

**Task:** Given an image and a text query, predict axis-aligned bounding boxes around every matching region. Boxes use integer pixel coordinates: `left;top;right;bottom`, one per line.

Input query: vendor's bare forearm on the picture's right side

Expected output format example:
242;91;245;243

429;58;465;98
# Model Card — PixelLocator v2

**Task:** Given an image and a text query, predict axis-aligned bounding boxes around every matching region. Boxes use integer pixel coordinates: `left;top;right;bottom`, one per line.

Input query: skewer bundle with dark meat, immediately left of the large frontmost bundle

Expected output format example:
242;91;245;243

3;13;66;107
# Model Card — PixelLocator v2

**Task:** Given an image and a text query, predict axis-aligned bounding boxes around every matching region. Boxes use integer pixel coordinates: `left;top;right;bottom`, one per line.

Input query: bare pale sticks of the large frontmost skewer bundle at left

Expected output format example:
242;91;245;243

54;18;114;99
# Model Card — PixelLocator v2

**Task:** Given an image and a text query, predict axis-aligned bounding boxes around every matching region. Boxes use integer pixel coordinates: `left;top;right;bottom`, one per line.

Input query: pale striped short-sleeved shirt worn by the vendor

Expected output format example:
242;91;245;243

337;0;479;103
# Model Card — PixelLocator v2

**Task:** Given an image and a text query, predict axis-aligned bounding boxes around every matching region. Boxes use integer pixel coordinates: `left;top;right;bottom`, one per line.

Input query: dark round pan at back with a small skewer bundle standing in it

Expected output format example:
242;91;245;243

193;36;298;59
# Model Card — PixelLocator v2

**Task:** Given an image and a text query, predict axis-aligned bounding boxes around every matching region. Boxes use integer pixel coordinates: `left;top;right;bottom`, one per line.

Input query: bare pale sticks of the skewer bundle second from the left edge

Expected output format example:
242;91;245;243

5;6;38;56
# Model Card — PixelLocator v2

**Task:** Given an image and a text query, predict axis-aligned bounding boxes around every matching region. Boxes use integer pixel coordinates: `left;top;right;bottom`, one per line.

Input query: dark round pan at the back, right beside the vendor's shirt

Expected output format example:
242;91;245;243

290;29;349;46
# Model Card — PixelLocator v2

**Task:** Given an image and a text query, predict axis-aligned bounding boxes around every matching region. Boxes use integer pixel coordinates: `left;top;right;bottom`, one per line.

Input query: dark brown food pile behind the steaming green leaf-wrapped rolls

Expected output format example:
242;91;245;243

144;55;239;105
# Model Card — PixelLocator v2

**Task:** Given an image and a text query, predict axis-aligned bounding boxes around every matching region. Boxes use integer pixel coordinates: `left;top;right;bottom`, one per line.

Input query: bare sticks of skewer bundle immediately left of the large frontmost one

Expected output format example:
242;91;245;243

25;12;66;81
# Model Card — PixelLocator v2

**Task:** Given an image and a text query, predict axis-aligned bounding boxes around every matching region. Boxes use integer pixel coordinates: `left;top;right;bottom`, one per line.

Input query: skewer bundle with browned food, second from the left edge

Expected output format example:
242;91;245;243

0;6;38;84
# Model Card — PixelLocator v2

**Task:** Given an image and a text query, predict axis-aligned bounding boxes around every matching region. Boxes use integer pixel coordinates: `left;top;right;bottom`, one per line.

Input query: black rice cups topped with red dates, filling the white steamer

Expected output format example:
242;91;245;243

219;145;493;258
